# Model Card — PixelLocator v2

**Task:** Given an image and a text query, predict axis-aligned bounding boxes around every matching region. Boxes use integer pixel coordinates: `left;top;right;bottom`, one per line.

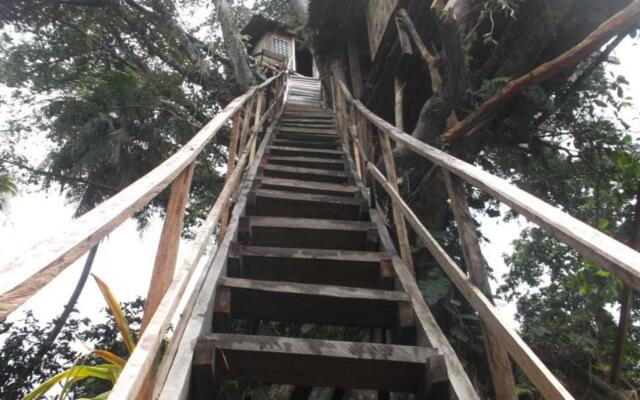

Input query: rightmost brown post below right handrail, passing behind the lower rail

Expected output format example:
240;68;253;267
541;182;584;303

443;169;518;400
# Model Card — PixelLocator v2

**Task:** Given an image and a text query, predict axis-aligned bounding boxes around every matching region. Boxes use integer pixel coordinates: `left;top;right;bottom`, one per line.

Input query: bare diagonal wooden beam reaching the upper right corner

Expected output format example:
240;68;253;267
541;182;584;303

442;0;640;142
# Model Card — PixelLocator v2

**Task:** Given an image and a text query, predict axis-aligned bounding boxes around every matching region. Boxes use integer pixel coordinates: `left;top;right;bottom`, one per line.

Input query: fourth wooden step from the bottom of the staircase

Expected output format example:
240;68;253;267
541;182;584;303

238;216;379;251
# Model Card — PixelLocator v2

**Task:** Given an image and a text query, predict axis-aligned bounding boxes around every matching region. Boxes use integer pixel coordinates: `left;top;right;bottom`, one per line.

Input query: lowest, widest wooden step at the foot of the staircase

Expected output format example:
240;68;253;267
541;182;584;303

192;334;449;400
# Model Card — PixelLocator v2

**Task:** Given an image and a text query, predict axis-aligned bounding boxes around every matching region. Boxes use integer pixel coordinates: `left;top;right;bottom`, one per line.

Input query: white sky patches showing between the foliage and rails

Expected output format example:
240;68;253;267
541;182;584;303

0;29;640;332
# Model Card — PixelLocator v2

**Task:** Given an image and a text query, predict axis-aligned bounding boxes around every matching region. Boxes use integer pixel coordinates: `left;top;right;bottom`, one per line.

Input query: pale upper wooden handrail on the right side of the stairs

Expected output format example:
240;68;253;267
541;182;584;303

338;81;640;291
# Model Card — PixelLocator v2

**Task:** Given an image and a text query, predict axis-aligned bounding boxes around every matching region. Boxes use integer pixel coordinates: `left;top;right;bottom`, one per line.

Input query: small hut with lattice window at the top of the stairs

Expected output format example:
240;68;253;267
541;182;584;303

241;15;318;78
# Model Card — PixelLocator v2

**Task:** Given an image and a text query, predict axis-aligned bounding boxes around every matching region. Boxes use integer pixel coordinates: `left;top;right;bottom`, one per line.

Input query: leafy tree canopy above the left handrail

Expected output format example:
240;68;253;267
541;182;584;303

0;0;234;226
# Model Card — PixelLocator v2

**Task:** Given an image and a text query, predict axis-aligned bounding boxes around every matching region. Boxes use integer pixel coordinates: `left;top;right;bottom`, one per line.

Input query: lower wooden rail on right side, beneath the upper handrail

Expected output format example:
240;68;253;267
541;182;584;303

367;163;573;399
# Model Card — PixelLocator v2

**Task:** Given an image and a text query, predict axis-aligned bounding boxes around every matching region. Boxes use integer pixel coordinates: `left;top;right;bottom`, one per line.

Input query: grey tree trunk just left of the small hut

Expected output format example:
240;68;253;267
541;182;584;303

215;0;255;92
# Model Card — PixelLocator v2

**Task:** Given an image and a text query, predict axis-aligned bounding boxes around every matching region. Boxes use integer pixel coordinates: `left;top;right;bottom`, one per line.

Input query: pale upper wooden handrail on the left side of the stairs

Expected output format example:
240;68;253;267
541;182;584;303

0;73;283;319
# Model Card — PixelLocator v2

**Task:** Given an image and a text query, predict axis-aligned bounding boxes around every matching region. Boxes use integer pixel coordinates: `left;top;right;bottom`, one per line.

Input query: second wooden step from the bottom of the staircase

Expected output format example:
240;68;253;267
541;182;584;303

213;277;415;335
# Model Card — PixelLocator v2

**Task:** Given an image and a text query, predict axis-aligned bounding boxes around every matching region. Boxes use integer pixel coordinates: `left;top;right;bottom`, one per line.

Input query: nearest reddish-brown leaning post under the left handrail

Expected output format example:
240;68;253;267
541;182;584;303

140;161;195;334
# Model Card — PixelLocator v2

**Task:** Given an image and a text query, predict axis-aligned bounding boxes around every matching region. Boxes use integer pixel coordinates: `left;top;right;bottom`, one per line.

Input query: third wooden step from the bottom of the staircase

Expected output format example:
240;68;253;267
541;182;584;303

227;242;395;290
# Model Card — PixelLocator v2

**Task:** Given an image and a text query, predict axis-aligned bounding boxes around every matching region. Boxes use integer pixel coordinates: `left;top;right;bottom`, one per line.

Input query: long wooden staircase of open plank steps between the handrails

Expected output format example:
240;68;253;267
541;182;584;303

190;76;449;399
